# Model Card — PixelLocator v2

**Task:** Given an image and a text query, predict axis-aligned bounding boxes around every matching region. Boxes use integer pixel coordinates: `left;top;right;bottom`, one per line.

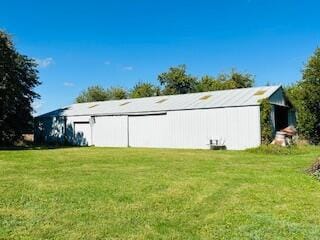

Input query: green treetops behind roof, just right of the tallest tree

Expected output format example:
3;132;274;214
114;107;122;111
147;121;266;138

197;69;254;92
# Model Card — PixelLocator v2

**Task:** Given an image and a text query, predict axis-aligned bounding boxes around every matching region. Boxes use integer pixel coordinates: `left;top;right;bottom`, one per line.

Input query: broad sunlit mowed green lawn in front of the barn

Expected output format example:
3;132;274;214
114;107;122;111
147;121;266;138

0;147;320;239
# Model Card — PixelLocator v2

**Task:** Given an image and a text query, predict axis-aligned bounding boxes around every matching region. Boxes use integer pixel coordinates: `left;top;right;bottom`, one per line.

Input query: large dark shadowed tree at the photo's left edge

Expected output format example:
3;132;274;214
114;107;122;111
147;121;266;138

0;31;40;146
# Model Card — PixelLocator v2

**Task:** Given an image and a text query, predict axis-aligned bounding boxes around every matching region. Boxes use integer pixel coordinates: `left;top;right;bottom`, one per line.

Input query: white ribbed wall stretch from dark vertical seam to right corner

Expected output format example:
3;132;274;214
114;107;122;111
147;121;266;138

129;106;260;149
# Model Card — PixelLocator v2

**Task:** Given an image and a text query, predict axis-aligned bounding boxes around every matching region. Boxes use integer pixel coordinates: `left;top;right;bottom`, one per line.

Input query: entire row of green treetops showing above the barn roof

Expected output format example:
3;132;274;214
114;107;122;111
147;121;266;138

76;65;254;103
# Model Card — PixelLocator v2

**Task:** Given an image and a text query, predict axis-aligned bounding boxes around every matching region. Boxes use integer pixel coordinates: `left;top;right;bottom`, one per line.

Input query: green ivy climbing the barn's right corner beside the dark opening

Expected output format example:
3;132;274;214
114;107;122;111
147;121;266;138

260;99;273;144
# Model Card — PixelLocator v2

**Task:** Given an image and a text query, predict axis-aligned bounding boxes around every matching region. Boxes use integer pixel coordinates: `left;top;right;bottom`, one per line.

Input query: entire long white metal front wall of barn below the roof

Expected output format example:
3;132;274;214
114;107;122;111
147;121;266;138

36;106;260;149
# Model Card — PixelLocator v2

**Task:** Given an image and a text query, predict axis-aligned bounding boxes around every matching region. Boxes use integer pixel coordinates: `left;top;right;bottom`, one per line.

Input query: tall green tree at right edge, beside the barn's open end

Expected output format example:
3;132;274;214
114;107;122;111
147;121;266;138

287;48;320;144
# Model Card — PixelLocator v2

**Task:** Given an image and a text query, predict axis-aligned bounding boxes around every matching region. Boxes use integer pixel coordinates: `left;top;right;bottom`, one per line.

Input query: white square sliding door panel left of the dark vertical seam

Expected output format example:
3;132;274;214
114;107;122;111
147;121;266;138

93;116;128;147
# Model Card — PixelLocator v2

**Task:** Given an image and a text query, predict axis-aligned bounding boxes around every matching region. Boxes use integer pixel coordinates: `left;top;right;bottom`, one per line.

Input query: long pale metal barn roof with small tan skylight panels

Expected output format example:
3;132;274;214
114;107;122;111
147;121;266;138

39;86;281;117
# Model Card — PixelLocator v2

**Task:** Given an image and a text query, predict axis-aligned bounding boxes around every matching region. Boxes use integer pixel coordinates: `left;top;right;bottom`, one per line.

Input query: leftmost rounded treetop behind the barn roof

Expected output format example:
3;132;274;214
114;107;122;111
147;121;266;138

76;85;109;103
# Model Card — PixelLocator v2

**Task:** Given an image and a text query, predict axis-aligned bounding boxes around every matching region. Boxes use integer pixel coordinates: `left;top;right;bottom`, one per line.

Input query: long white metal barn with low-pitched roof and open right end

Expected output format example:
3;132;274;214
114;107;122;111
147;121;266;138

35;86;294;149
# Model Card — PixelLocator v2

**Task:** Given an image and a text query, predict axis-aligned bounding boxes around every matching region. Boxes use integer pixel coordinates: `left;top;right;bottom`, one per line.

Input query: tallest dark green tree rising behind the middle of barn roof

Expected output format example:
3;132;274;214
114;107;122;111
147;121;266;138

158;65;197;95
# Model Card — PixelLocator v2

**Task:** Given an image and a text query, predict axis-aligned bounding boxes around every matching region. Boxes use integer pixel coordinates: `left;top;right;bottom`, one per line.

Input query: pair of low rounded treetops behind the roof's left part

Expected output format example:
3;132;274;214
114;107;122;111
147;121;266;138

76;85;128;103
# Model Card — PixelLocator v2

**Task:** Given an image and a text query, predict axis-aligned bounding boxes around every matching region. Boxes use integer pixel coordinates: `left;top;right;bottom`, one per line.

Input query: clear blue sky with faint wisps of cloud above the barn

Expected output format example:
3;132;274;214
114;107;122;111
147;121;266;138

0;0;320;114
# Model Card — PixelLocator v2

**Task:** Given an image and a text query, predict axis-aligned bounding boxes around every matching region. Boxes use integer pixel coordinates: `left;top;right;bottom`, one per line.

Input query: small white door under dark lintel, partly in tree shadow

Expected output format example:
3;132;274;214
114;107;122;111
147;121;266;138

74;122;92;146
